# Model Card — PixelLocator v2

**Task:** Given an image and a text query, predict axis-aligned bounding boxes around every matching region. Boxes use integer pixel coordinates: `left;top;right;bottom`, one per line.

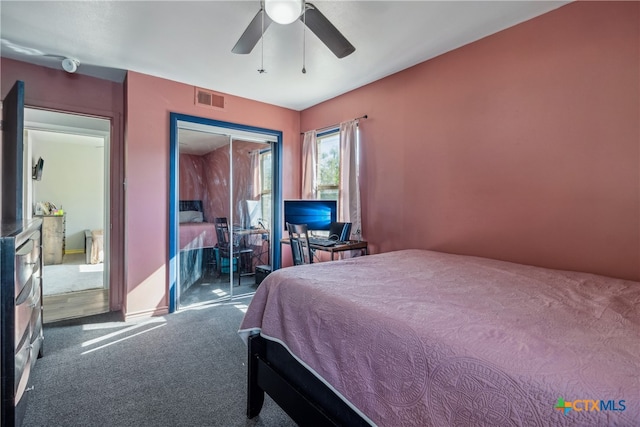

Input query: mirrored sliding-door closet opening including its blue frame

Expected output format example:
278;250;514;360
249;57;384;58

169;113;282;312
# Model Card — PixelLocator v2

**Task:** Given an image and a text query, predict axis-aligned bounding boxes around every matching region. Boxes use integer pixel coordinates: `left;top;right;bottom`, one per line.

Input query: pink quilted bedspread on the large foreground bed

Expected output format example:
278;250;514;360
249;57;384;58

240;250;640;426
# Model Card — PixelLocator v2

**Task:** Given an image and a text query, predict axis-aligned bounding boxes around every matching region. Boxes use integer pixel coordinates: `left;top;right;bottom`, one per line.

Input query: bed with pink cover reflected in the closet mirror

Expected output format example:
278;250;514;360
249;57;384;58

178;200;217;292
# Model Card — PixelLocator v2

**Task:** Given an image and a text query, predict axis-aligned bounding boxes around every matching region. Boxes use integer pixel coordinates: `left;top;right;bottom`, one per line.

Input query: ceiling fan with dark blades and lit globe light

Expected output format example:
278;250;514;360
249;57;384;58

231;0;356;58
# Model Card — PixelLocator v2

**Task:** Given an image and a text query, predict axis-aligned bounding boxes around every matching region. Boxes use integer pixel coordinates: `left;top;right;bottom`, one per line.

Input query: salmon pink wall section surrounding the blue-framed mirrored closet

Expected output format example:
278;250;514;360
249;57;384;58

125;72;300;317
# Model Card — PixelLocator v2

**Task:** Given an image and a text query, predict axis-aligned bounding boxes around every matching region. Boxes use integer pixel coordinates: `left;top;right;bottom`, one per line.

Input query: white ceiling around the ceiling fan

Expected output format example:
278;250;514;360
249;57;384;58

0;0;567;110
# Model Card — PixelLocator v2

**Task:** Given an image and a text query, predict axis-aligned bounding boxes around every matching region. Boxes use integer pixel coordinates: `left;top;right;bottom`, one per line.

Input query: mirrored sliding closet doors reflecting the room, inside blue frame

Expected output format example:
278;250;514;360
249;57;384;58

178;128;273;307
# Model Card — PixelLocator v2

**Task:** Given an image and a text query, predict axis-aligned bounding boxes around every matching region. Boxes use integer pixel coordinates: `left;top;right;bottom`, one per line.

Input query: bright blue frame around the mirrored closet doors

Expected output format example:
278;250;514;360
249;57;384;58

167;112;283;313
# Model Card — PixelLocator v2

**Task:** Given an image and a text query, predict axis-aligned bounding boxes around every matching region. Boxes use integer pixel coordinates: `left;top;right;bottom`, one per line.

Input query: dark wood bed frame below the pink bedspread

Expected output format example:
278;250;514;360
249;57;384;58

247;334;370;426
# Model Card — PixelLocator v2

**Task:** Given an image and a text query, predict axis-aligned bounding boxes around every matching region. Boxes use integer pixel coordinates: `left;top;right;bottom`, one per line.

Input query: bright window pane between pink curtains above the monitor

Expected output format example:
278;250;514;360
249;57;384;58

316;129;340;200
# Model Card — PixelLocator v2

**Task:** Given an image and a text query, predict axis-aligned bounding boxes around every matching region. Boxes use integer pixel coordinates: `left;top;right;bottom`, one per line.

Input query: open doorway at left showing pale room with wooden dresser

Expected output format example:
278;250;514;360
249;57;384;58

23;108;111;322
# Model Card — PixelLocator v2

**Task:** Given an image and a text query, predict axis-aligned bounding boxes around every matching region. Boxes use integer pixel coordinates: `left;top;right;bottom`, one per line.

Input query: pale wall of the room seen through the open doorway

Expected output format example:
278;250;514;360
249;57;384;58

29;130;104;251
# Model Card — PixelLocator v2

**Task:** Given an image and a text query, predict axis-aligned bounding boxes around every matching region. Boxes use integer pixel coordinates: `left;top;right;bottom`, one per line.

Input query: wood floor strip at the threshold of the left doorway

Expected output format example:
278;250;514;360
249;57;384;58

43;289;109;323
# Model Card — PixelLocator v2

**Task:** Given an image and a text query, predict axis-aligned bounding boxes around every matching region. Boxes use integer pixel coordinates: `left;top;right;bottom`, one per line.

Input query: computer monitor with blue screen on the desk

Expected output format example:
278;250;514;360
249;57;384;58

284;200;338;231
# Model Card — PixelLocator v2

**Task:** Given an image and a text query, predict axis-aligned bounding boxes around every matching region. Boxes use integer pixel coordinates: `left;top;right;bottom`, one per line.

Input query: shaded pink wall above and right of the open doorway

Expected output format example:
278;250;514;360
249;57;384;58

0;58;125;311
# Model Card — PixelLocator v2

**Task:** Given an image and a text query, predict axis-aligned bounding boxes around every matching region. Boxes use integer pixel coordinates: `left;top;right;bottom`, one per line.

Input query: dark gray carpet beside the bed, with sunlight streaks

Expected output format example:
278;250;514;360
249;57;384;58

23;298;295;427
